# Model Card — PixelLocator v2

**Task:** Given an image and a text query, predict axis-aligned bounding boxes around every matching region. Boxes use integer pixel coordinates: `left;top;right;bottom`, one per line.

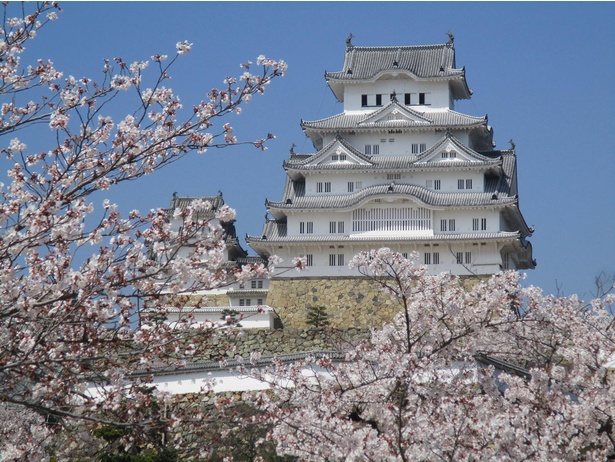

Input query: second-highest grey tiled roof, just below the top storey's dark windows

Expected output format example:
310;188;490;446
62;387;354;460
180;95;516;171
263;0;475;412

301;106;487;131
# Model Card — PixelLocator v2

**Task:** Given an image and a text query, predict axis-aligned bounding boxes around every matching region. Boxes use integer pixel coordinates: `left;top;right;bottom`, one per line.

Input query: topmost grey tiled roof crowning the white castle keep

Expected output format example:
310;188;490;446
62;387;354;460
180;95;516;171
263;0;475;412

325;44;464;80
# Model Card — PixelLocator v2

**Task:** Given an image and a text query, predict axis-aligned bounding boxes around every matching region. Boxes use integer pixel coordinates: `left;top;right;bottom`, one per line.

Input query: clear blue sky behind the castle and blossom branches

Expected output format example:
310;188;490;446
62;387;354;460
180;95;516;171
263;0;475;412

10;2;615;298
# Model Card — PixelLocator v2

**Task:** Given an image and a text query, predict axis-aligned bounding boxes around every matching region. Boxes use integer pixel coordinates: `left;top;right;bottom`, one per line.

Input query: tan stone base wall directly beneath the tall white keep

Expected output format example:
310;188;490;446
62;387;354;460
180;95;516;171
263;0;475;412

267;276;402;329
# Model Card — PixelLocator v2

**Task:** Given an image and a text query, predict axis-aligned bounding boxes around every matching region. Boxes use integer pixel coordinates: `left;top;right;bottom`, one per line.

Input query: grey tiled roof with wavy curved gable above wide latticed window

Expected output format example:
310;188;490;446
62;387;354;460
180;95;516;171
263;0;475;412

265;184;516;210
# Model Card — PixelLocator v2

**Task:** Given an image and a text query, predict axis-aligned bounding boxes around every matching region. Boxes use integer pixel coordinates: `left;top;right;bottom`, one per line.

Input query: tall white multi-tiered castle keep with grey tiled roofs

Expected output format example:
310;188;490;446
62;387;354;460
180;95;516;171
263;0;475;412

247;34;536;278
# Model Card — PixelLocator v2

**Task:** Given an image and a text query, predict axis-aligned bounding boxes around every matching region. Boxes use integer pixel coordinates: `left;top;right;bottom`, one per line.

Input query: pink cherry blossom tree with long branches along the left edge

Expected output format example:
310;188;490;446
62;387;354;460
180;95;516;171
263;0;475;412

0;3;286;460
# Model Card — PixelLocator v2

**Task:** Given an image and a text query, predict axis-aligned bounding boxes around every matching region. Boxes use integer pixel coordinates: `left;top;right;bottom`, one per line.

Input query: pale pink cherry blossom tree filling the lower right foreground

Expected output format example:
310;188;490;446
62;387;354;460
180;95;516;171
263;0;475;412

257;249;615;461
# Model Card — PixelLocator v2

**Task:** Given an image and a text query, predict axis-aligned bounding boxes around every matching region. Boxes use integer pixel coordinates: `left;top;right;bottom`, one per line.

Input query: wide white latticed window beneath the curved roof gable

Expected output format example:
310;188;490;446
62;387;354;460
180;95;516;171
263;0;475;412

352;207;432;232
